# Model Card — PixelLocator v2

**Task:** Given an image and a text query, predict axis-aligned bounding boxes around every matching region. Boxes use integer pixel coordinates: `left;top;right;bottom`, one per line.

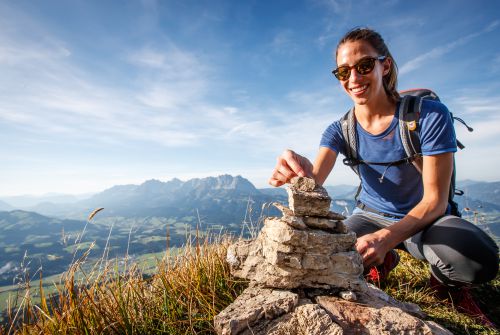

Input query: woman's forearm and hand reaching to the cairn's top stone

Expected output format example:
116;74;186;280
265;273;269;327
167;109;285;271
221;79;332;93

269;147;337;187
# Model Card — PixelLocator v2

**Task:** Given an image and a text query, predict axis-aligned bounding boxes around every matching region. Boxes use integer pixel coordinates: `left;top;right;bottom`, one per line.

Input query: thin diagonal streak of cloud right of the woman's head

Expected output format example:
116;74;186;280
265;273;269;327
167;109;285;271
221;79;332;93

399;20;500;75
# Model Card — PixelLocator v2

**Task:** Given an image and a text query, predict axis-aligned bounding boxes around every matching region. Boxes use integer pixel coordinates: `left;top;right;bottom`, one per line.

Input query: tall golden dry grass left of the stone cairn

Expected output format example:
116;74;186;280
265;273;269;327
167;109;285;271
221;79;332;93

0;234;246;334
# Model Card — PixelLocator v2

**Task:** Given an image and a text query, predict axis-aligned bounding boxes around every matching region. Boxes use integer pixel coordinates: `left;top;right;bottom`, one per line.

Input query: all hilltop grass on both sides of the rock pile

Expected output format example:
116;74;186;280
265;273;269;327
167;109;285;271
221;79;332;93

0;232;500;335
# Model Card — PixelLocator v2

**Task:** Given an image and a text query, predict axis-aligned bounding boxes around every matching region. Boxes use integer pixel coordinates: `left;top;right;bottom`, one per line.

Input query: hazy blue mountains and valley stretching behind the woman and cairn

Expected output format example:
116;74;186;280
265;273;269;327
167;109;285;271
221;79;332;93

0;175;500;284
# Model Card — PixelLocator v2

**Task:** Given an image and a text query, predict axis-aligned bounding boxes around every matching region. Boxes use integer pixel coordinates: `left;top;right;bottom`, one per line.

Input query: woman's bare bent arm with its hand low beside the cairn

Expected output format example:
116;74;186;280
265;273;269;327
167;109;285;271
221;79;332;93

356;152;453;266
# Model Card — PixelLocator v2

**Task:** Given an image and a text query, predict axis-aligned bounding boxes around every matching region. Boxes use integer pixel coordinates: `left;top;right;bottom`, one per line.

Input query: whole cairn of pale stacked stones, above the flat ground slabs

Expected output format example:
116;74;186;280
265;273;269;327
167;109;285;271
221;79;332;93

227;177;366;291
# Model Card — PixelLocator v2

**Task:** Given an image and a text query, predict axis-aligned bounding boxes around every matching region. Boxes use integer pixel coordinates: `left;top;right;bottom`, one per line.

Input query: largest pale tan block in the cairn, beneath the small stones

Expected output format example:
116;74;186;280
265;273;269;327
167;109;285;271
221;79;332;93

226;218;366;290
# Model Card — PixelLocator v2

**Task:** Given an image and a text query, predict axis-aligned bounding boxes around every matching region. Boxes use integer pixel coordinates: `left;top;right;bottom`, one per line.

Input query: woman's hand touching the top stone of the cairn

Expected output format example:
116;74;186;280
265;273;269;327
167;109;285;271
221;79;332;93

269;149;313;187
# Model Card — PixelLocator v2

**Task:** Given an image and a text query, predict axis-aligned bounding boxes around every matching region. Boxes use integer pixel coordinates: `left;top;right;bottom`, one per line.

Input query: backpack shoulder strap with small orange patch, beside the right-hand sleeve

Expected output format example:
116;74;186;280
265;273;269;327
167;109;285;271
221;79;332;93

399;95;423;174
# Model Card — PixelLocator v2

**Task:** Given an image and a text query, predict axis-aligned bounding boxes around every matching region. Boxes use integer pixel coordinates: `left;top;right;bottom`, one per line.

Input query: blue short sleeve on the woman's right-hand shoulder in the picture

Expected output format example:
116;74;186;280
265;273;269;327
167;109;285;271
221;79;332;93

420;100;457;156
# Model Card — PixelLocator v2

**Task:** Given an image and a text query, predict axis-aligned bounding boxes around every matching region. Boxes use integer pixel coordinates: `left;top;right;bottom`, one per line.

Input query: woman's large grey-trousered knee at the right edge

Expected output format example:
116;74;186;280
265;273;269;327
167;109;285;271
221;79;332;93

422;216;499;283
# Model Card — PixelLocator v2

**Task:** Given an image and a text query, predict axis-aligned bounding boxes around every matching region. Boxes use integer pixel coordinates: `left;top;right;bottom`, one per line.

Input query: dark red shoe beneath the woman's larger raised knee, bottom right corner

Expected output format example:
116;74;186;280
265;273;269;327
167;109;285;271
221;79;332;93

429;274;496;329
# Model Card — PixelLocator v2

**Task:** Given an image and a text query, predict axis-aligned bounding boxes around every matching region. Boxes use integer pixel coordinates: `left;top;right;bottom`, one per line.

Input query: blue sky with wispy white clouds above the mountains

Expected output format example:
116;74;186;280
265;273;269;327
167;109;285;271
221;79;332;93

0;0;500;195
